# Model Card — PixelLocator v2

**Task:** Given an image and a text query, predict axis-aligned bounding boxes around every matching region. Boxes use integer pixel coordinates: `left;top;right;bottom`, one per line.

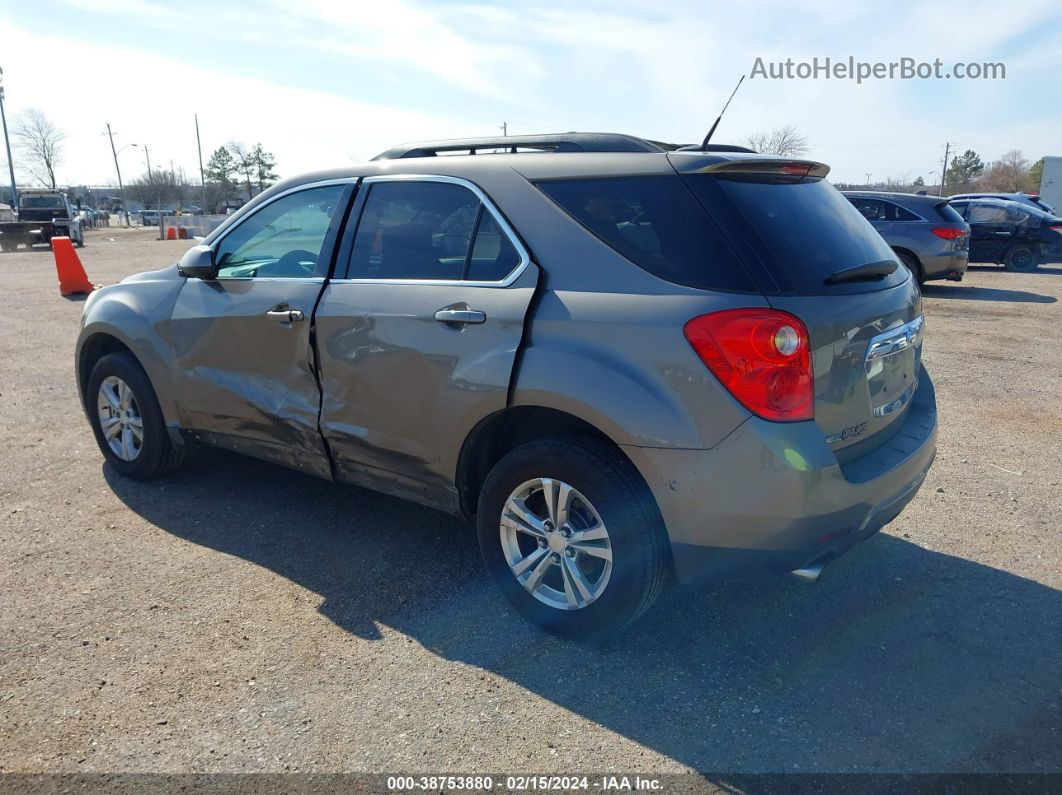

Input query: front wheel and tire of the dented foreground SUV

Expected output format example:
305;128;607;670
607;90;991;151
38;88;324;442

85;352;184;480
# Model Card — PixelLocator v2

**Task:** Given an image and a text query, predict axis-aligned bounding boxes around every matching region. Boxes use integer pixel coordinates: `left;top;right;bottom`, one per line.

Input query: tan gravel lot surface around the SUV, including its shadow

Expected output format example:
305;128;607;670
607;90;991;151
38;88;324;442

0;230;1062;780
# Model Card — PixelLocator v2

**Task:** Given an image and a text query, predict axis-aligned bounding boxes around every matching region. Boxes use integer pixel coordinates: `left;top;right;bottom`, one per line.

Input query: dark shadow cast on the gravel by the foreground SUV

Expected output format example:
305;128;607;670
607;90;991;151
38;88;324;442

104;451;1062;780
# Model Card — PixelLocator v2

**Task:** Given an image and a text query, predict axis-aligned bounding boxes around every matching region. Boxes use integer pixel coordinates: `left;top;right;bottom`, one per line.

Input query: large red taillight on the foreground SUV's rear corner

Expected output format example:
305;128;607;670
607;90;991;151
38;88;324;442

683;309;815;422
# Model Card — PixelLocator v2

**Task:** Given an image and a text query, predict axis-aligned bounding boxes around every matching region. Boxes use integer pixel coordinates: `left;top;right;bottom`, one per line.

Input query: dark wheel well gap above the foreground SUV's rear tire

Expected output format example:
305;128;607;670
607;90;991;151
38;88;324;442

457;405;622;516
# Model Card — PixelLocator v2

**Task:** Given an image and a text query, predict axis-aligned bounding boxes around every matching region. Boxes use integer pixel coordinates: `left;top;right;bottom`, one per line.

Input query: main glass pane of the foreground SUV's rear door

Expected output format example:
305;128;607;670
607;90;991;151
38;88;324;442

347;180;480;279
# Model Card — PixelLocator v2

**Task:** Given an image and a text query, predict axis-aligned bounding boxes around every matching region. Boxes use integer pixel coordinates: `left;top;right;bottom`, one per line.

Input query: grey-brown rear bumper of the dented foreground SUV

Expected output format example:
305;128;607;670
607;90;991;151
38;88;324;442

624;369;937;583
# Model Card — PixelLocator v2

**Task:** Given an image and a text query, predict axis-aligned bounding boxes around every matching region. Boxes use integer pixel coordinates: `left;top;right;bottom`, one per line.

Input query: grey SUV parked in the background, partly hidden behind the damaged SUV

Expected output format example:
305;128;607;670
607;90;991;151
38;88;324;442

843;190;970;284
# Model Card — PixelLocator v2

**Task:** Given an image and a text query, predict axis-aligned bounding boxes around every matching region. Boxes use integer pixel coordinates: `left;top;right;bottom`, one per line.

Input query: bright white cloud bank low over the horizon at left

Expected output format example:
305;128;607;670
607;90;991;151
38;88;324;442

0;21;483;184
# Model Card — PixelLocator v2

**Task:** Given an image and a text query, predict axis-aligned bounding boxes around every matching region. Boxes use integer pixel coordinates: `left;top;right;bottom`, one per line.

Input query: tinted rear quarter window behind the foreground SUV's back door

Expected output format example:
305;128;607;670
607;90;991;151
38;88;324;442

536;175;755;292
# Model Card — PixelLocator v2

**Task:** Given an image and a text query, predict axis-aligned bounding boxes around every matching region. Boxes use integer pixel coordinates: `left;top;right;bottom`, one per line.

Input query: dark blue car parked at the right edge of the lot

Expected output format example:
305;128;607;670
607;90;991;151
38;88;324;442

952;198;1062;271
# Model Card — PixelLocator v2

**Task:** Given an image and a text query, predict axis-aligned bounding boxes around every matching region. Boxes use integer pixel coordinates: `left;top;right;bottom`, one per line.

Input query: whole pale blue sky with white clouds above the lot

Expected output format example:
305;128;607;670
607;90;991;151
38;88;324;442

0;0;1062;184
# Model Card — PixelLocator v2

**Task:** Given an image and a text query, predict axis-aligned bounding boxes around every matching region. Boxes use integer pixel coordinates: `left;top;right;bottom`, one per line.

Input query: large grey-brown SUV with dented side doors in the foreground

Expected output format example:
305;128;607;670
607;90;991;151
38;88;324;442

75;134;937;638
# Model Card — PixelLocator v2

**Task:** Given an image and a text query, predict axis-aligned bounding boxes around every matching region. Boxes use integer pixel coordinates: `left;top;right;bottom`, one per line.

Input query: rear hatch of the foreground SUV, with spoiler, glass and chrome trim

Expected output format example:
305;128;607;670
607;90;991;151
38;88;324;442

669;153;922;464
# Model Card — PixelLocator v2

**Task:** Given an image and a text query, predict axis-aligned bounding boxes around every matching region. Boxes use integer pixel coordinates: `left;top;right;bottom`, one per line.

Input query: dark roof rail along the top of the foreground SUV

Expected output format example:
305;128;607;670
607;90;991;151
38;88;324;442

373;133;675;160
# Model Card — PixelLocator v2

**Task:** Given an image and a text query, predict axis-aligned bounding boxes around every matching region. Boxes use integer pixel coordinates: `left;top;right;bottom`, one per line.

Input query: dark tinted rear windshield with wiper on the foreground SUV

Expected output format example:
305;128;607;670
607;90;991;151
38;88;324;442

683;174;906;295
